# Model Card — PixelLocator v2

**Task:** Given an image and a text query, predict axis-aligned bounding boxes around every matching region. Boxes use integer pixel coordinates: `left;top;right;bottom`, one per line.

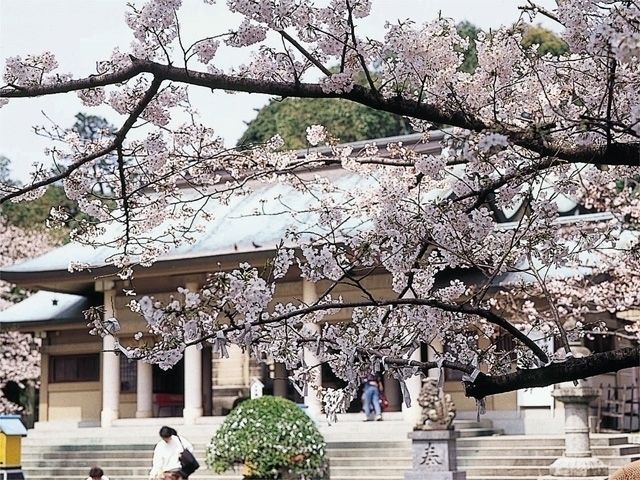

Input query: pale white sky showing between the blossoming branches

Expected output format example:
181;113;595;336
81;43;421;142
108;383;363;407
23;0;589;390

0;0;554;181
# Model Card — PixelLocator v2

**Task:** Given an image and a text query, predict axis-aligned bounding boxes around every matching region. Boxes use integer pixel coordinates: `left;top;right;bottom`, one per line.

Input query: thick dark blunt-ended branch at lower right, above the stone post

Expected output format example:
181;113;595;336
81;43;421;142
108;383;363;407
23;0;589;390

465;346;640;399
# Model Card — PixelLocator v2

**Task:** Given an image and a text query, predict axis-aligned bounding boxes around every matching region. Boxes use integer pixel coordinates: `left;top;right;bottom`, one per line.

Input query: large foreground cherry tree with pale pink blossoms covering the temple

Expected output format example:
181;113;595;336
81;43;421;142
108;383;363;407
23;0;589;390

0;0;640;408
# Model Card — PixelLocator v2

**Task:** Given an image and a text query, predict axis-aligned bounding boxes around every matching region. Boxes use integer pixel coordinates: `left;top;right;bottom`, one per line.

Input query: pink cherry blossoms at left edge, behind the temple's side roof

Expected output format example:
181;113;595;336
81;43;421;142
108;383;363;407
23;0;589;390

0;219;52;413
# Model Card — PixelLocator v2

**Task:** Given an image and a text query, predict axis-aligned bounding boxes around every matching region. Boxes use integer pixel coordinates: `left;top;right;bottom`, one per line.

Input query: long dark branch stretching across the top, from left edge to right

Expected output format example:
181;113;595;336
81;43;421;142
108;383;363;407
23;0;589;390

0;58;640;166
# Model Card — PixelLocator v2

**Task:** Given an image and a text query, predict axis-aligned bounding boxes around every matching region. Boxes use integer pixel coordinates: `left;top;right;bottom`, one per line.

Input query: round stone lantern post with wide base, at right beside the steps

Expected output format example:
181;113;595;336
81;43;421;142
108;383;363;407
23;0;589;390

543;384;609;480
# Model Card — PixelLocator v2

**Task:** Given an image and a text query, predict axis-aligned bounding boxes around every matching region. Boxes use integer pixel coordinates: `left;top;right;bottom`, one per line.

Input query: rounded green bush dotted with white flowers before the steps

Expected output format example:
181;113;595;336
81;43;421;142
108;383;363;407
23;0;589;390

207;396;327;479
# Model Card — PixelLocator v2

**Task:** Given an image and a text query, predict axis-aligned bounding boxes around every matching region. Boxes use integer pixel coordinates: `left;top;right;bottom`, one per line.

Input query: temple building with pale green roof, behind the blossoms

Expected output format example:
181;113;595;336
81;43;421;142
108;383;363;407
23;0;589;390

0;133;640;433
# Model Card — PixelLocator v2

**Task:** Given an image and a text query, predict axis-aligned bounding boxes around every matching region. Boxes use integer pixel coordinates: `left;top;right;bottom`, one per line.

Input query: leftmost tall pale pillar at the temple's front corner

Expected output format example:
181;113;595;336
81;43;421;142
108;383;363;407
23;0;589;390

100;289;120;427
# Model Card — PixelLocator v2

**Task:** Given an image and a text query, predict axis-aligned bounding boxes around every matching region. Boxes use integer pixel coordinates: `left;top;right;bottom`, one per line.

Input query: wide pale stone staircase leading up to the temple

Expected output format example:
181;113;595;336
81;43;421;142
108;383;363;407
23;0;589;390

17;414;640;480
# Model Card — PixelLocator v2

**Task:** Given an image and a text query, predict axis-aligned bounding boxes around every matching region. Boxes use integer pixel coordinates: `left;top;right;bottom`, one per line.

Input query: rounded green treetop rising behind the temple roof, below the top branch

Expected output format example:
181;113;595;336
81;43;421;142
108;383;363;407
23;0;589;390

238;98;411;149
